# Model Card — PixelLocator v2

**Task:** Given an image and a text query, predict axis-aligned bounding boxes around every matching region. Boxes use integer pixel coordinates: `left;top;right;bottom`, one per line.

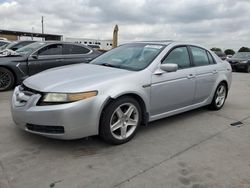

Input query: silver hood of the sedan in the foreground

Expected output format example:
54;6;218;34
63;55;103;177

24;64;133;93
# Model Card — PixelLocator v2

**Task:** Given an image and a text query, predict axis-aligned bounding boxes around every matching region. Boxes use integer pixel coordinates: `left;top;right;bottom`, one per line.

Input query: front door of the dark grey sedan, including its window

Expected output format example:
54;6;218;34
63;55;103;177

28;44;63;75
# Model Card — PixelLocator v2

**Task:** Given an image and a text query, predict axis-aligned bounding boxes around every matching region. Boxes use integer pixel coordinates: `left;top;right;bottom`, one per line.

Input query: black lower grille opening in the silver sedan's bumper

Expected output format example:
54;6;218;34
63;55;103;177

26;123;64;134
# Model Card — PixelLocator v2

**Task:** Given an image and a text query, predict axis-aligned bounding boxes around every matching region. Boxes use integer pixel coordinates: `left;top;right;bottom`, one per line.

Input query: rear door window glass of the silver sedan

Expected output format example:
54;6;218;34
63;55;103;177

191;47;209;66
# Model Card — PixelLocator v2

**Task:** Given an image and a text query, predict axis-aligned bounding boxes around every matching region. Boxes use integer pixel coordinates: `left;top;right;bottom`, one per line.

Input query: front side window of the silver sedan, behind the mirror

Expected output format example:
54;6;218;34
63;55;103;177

162;47;190;69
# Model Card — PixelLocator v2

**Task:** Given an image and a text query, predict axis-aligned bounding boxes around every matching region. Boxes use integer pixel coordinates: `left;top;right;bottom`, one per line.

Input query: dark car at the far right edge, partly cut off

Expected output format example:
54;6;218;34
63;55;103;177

228;52;250;73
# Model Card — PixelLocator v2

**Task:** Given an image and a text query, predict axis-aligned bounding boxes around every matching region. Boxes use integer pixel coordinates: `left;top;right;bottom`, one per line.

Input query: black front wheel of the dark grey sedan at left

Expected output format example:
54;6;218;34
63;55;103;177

0;67;15;91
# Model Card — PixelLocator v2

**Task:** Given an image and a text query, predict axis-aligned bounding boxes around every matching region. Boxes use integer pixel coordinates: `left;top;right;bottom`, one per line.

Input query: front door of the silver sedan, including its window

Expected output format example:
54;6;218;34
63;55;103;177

150;46;196;116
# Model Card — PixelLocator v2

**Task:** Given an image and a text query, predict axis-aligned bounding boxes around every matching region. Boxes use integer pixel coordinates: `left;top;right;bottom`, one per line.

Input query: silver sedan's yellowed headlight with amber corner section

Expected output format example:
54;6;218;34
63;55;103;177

42;91;97;103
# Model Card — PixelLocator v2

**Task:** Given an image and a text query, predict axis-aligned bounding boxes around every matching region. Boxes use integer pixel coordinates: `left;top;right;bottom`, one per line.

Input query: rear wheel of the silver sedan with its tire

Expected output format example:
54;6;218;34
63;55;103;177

209;82;228;110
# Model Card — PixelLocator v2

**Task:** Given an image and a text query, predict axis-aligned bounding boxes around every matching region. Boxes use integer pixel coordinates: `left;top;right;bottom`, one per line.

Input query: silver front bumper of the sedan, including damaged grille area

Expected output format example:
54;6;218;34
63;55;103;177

11;86;101;139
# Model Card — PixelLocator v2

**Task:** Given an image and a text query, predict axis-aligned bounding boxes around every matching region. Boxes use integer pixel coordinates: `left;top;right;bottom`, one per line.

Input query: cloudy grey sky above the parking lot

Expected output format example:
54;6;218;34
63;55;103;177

0;0;250;50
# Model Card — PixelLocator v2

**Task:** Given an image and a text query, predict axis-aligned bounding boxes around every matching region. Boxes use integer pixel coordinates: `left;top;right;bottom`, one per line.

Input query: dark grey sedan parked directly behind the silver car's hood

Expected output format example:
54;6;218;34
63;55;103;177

0;41;101;91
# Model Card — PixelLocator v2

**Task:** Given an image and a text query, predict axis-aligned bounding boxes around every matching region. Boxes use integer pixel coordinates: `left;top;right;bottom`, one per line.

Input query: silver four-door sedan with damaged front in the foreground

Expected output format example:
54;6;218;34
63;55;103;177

12;41;232;144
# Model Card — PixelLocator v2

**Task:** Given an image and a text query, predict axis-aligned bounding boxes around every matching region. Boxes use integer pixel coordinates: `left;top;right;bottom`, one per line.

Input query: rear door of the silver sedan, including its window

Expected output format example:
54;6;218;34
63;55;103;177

190;46;218;103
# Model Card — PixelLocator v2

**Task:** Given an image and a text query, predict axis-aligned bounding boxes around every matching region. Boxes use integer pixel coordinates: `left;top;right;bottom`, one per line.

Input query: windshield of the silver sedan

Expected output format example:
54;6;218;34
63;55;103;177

91;43;165;71
